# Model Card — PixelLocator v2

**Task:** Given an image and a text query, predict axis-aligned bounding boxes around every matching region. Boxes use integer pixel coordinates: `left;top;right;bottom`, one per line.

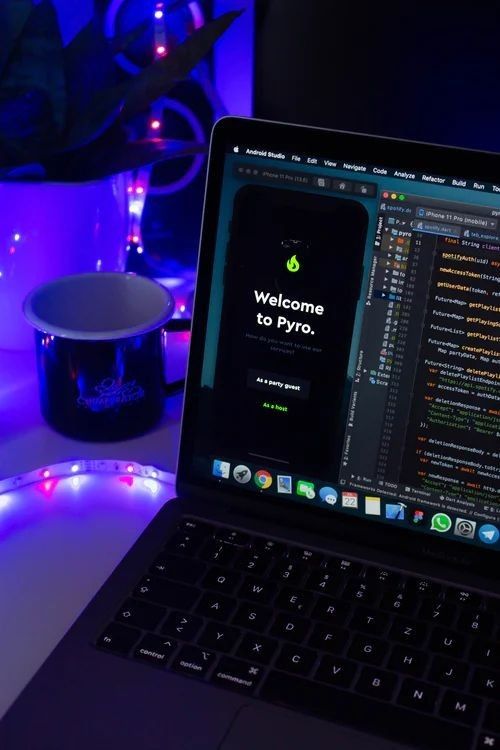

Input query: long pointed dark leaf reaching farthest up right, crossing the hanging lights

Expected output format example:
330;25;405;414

121;11;242;118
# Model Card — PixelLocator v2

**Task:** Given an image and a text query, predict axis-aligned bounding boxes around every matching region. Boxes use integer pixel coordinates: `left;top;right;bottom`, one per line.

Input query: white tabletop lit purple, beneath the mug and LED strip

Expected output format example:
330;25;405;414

0;334;188;716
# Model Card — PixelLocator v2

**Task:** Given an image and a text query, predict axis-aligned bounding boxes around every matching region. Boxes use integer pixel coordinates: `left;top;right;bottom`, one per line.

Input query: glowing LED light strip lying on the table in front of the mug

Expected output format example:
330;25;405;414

0;459;175;505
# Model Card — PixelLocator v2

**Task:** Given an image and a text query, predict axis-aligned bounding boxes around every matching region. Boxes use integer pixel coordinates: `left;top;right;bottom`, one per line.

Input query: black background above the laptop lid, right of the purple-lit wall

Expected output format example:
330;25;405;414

254;0;500;150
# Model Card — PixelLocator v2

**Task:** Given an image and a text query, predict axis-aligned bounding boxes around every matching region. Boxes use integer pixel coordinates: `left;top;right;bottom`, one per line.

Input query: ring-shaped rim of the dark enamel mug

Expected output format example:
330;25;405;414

23;271;175;341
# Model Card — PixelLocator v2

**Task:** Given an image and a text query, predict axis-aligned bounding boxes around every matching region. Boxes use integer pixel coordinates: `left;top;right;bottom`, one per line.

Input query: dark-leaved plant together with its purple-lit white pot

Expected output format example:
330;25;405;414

0;0;239;348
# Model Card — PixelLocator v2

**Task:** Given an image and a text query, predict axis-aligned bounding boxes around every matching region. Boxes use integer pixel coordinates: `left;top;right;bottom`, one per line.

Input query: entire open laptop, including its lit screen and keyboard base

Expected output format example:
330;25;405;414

0;117;500;750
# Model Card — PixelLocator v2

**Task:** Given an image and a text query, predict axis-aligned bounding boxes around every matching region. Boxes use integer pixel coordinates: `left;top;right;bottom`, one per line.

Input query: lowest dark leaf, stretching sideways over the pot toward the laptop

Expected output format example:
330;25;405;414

45;138;206;182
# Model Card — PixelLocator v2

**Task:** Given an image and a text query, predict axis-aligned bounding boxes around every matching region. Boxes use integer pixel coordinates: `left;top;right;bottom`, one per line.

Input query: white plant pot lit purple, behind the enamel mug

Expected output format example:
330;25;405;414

0;175;128;349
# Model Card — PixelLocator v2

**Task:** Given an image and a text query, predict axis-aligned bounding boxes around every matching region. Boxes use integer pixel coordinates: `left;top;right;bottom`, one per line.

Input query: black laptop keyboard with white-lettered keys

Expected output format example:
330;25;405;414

96;517;500;750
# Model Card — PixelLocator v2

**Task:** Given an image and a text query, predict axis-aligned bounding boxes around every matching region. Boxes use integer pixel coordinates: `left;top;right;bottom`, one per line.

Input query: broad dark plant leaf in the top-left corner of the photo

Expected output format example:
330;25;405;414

0;0;66;133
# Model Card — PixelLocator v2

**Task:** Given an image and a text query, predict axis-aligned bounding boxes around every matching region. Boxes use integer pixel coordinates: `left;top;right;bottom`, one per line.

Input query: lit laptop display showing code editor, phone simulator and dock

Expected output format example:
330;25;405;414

184;120;500;549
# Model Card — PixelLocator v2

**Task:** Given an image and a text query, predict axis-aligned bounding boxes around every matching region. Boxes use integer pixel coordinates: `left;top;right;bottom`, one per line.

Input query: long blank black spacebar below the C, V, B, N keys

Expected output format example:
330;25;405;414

260;672;473;750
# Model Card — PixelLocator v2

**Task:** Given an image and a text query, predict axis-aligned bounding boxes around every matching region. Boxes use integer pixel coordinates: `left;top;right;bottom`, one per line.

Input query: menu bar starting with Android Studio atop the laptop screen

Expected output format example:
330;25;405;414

231;145;500;196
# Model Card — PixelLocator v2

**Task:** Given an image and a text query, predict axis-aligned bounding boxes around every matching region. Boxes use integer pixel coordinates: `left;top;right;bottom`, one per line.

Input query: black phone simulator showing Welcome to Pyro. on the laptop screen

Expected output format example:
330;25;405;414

214;185;368;474
